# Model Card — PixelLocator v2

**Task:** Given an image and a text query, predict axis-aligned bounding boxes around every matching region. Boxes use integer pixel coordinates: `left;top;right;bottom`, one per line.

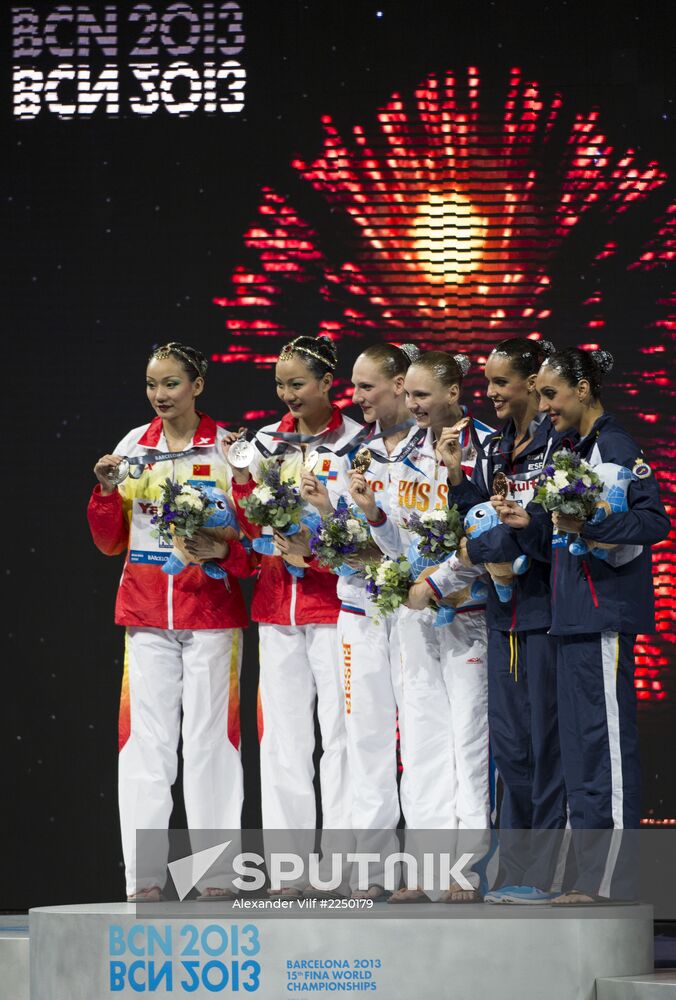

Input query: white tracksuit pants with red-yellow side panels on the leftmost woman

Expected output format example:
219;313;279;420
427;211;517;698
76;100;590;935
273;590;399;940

119;628;243;895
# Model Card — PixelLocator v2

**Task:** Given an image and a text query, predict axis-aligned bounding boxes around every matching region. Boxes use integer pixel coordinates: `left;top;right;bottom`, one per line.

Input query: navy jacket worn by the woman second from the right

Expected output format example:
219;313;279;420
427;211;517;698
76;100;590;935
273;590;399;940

448;416;571;632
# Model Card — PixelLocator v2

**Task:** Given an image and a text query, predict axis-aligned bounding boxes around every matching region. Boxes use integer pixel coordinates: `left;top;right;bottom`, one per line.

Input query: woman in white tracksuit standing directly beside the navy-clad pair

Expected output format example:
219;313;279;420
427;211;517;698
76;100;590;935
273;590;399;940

352;351;490;902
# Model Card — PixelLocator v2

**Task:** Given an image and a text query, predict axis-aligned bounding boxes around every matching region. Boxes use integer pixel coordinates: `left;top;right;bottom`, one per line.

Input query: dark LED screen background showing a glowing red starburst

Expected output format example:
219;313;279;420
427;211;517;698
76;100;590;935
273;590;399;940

2;0;676;908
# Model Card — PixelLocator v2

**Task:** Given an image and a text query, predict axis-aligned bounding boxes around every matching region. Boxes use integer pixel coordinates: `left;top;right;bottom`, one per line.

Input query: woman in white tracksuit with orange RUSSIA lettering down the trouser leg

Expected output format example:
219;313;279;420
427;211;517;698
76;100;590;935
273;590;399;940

338;344;420;899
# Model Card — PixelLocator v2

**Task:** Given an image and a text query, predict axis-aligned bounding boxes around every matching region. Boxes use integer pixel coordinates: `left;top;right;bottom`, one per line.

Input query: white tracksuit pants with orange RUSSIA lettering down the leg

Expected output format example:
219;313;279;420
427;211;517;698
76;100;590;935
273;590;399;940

338;611;399;889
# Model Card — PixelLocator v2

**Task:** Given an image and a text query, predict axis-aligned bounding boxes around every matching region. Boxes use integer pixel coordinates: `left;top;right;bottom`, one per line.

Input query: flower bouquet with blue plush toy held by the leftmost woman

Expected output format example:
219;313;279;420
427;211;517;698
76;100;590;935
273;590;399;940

151;479;239;579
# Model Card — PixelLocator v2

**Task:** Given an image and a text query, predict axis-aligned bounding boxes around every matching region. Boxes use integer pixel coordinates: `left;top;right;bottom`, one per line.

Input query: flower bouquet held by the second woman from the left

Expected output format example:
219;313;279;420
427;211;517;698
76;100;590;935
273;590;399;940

240;462;305;577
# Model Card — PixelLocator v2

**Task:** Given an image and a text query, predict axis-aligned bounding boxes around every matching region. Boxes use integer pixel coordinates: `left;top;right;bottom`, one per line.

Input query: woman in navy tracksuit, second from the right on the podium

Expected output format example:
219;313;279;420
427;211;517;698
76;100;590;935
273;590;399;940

432;338;566;903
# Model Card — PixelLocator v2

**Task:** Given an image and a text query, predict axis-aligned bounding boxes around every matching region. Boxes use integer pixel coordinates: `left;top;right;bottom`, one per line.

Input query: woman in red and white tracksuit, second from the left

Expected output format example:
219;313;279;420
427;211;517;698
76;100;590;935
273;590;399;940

228;337;361;868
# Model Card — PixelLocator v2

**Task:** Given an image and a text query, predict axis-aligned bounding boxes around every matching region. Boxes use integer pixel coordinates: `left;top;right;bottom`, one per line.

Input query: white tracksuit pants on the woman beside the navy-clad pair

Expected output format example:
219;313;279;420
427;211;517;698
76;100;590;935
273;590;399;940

396;608;490;830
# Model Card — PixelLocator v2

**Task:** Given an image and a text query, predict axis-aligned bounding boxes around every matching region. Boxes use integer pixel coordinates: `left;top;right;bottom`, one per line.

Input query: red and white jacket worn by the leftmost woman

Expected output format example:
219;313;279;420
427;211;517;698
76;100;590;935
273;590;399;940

87;414;252;629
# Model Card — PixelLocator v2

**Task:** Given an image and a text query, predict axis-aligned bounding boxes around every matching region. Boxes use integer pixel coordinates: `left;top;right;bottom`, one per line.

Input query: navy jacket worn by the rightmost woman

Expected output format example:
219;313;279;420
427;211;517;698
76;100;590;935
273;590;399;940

522;413;670;635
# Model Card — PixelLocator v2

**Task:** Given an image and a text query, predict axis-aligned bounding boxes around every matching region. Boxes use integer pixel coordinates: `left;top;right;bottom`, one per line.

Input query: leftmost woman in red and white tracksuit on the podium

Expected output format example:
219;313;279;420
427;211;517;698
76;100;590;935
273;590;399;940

87;343;250;901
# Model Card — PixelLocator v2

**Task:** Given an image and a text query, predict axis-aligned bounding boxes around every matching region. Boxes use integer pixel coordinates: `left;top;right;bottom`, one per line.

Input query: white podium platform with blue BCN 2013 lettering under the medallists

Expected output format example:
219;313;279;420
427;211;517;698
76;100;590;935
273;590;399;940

26;903;653;1000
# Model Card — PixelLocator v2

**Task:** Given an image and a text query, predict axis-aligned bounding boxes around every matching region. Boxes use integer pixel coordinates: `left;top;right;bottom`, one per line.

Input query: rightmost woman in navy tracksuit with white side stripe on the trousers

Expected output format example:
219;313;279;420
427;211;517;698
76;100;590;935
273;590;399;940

500;348;670;903
